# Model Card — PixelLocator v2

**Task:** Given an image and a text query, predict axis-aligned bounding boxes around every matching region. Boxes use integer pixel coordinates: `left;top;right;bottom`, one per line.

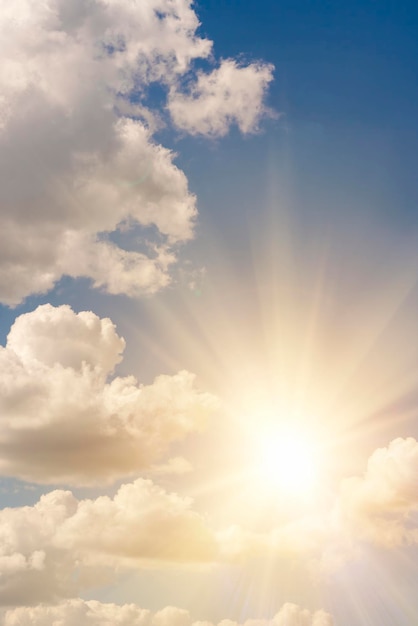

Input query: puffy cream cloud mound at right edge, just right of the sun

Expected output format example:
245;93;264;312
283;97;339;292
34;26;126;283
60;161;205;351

337;437;418;547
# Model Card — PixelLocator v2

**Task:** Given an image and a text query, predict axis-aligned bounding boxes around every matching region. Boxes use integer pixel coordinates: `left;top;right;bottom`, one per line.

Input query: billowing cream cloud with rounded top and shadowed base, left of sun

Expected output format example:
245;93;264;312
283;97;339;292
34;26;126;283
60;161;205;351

0;304;217;484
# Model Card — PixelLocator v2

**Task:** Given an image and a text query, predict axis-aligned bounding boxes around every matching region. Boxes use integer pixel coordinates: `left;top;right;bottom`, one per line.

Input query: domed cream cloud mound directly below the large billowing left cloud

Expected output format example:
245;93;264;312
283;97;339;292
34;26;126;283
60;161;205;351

55;479;216;563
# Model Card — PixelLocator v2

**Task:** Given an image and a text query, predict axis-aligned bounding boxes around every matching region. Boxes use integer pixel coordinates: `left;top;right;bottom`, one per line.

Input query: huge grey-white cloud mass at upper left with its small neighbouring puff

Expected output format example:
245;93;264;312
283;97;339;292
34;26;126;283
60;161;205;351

0;0;271;305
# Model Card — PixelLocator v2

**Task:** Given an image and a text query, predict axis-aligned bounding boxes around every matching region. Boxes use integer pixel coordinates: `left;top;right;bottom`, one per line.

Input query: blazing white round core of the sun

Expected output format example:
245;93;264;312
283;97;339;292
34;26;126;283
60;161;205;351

257;431;317;495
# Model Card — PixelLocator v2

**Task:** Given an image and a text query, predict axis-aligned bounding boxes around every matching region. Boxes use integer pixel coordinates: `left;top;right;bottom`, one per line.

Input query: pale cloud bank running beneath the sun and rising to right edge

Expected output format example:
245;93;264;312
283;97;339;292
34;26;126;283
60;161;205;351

216;437;418;576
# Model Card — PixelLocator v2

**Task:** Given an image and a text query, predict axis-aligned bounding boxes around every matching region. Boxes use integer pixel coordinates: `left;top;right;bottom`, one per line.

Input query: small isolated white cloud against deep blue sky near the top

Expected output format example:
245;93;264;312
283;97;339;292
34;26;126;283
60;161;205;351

168;59;273;137
